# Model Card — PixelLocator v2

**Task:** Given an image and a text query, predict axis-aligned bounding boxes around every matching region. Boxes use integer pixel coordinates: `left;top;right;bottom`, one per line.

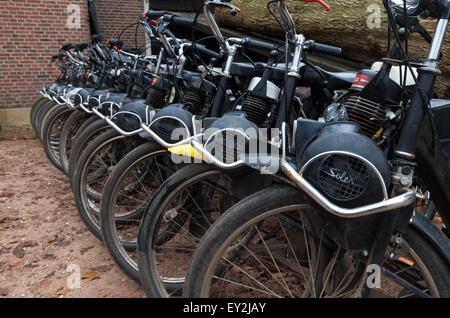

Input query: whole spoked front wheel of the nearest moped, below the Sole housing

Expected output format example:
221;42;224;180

183;185;450;298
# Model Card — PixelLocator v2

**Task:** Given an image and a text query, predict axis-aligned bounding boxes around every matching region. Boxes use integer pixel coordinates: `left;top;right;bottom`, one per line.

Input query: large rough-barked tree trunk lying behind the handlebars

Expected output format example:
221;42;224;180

216;0;450;98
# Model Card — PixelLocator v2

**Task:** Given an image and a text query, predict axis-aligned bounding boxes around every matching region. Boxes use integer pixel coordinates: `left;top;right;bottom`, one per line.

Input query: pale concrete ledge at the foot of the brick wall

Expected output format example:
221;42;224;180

0;107;36;138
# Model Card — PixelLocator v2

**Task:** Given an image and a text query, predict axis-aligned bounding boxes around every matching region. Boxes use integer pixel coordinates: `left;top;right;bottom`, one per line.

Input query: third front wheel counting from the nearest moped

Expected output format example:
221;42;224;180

100;141;173;282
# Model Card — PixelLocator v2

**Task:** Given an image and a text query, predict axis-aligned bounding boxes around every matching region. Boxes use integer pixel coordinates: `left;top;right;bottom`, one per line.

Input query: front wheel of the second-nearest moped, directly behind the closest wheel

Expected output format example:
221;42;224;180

138;164;238;297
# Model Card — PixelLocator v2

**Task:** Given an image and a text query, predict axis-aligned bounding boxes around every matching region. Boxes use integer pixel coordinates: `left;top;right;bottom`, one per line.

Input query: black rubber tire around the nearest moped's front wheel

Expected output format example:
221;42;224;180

183;185;450;298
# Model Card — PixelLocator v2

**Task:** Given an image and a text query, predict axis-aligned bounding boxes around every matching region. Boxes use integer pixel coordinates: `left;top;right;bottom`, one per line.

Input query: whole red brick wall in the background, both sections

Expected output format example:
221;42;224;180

0;0;145;108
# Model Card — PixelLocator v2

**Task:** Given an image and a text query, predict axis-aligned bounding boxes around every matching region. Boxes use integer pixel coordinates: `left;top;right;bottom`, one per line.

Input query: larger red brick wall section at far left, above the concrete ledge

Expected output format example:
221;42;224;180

0;0;90;108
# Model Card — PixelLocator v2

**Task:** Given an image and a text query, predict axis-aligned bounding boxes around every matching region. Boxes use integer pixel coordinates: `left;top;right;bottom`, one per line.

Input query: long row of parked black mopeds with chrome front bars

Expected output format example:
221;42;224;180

30;0;450;297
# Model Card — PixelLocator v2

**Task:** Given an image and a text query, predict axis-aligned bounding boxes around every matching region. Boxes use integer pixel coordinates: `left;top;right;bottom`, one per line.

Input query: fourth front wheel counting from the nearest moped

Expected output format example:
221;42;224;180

72;129;142;240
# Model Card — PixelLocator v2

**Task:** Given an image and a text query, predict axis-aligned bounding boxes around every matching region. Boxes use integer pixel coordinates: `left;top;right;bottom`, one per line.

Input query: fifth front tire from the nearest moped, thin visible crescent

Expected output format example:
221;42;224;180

68;116;111;187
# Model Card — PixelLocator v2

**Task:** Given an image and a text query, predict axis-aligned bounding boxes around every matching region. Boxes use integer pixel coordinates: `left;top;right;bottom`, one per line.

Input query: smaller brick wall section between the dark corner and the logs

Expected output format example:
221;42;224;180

94;0;145;47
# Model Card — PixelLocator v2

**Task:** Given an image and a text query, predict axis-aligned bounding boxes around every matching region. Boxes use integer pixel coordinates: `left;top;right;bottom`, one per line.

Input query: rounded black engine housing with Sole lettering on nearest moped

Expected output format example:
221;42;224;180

296;120;390;251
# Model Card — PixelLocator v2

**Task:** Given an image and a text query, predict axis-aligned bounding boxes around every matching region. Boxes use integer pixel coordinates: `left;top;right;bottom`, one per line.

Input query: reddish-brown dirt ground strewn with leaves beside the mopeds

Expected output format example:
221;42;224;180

0;139;145;298
